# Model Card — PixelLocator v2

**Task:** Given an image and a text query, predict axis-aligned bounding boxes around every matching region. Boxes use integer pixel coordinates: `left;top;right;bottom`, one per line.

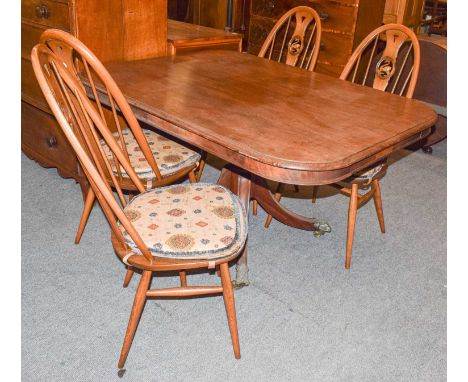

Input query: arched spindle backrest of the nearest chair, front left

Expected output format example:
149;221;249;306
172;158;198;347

31;40;153;263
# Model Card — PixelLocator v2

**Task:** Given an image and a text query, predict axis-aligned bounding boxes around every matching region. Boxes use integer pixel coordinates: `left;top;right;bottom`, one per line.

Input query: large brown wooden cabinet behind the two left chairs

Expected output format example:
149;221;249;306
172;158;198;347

21;0;167;188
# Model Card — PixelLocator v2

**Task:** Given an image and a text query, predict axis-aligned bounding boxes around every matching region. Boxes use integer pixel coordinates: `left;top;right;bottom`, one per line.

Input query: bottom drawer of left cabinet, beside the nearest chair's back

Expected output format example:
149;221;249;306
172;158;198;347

21;102;78;176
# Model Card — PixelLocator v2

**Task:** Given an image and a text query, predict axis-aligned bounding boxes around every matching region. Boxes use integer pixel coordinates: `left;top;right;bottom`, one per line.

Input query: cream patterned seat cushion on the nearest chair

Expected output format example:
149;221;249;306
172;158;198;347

121;183;247;259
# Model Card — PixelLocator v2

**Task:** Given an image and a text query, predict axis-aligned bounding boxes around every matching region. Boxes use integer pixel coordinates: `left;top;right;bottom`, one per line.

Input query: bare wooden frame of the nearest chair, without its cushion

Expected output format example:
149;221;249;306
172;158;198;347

31;44;242;368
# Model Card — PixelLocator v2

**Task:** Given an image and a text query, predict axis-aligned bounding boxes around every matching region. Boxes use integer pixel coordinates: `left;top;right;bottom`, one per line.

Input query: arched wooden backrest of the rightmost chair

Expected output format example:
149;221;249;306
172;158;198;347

340;24;420;98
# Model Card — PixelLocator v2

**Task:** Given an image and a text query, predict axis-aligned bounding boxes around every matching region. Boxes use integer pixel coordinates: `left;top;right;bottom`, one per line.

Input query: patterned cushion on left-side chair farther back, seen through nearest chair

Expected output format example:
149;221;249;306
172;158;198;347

101;129;200;180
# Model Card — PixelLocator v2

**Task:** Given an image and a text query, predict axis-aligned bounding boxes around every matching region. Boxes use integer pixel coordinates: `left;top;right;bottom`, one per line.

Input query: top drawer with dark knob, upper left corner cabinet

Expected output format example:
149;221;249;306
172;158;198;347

21;0;70;30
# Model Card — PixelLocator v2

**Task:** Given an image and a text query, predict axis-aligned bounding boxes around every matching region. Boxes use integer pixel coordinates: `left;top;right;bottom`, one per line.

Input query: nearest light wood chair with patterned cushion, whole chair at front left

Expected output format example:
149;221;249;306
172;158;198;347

31;44;247;368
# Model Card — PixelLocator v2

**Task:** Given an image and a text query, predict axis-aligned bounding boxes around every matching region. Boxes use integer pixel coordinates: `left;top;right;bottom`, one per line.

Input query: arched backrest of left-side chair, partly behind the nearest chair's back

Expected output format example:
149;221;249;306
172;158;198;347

40;29;162;180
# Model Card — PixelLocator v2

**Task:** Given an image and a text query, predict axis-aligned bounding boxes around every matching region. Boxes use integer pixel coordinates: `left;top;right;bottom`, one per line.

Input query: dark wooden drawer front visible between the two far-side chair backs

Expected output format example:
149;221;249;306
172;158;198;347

317;32;353;66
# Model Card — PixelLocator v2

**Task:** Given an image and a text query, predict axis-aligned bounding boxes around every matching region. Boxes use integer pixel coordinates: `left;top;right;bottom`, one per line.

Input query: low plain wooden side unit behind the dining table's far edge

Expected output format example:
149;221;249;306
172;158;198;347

167;20;242;54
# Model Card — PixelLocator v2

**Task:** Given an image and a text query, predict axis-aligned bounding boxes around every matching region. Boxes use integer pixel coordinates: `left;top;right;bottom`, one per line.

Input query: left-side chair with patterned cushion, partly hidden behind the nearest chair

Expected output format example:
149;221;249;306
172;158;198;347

40;29;206;244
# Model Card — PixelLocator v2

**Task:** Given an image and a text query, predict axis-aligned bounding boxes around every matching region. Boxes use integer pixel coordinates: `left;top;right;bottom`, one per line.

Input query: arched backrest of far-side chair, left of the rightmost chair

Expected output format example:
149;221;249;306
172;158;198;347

258;6;322;71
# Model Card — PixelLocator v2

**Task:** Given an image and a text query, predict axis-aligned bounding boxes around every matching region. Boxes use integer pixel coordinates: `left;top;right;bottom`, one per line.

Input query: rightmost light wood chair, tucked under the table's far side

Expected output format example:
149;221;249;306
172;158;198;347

265;24;420;269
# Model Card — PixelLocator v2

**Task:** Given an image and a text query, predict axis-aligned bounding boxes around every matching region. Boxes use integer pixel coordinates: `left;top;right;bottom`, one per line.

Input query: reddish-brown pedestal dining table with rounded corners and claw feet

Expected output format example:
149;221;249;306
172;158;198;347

97;50;437;286
